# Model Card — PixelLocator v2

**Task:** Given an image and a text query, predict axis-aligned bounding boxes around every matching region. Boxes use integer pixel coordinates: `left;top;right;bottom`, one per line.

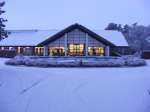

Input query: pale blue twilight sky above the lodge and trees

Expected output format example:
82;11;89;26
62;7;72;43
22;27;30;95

4;0;150;29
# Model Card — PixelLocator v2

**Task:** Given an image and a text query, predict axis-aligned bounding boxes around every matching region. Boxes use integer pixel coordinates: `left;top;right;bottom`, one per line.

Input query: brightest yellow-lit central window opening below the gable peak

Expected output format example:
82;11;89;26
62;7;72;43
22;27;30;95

68;44;85;56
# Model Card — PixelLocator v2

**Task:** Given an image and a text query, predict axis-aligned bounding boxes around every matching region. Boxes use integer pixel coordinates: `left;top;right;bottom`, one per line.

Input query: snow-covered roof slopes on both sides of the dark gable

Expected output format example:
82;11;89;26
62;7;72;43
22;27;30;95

0;30;128;46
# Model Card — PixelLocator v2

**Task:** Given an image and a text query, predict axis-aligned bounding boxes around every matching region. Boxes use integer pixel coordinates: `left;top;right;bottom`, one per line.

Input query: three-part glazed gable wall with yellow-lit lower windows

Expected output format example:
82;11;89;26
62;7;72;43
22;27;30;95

48;29;105;56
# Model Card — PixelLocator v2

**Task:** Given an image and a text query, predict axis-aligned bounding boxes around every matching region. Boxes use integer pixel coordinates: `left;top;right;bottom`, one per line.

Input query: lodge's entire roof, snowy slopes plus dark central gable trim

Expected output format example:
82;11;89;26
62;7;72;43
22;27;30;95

0;24;128;46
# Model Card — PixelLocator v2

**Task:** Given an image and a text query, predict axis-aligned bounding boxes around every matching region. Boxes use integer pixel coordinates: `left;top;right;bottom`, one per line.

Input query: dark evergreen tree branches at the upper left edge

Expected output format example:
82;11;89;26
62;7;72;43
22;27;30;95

0;1;8;40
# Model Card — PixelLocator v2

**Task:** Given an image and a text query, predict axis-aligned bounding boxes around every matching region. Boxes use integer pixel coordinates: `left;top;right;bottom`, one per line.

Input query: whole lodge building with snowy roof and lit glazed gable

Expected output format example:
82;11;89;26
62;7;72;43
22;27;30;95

0;24;132;56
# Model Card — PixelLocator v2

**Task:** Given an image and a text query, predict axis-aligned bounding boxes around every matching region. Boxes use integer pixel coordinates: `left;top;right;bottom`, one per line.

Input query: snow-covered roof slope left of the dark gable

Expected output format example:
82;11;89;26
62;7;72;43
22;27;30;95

0;30;58;46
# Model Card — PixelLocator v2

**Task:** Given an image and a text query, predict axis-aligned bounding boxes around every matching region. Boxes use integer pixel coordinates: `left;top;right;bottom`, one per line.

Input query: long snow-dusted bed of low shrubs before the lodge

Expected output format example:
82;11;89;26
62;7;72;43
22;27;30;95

6;56;146;67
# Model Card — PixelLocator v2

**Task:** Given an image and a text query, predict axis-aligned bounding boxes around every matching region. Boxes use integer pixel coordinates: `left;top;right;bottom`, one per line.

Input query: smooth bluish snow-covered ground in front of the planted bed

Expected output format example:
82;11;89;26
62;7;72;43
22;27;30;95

0;59;150;112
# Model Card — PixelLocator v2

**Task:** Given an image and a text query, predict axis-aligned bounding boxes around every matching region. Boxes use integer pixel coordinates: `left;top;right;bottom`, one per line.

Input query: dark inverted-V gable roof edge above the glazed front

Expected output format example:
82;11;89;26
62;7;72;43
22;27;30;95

38;24;115;46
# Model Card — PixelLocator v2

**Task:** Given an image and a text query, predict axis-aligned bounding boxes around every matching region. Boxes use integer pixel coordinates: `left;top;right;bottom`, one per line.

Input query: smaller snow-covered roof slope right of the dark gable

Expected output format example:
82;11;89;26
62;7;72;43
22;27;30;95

94;30;128;46
